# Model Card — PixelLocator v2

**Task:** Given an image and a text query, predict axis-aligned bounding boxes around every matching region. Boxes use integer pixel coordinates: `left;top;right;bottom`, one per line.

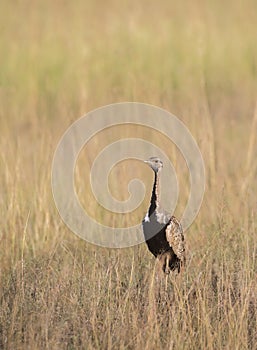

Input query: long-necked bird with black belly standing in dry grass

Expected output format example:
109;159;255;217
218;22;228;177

142;157;185;274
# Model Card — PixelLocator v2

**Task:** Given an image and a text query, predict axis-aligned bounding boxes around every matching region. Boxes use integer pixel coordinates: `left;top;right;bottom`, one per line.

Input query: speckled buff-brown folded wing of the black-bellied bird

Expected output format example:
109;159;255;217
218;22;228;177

166;216;185;262
